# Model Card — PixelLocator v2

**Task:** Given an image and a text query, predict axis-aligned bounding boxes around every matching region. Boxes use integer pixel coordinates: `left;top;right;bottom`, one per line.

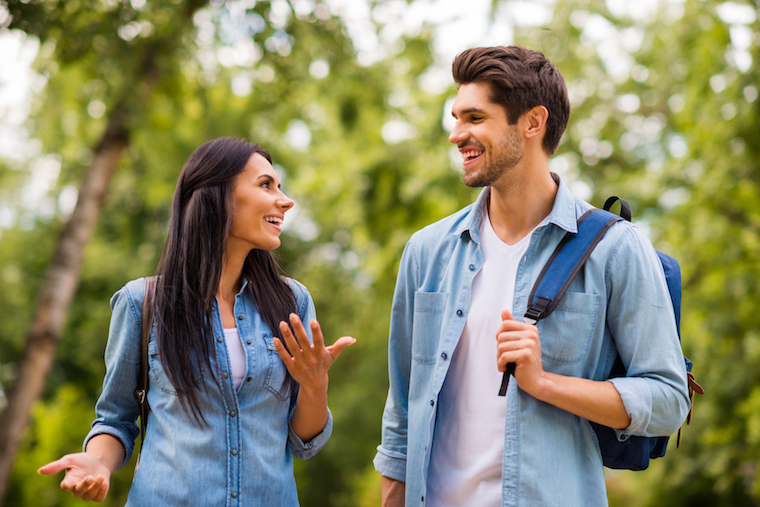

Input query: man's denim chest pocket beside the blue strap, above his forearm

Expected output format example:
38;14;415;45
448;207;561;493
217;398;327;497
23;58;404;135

538;292;601;372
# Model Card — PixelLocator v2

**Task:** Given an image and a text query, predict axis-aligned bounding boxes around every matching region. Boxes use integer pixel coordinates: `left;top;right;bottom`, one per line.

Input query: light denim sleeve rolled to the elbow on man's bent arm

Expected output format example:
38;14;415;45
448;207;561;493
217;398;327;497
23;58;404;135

606;227;689;440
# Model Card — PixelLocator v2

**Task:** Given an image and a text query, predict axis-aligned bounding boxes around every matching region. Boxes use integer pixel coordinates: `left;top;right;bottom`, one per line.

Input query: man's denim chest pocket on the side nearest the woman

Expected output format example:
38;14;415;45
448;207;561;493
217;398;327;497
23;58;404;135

412;292;449;364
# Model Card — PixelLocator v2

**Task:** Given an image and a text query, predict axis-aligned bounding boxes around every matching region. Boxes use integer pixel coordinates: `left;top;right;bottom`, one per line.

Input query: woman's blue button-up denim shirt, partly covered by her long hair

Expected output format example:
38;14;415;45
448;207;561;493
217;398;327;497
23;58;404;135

84;278;332;507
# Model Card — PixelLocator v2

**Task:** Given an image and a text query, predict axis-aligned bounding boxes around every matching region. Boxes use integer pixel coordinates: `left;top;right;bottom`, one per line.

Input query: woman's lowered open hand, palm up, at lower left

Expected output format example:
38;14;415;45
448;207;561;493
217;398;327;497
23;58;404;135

37;452;111;502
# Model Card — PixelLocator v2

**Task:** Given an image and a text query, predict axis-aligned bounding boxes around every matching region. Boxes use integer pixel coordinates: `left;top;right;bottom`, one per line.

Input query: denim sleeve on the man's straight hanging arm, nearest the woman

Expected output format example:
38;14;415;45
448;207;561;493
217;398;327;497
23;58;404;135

373;238;419;481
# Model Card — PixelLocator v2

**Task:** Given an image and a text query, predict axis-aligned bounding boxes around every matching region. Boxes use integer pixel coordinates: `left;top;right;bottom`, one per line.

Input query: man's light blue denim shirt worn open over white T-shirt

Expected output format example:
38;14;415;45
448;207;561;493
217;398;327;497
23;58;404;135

374;175;689;507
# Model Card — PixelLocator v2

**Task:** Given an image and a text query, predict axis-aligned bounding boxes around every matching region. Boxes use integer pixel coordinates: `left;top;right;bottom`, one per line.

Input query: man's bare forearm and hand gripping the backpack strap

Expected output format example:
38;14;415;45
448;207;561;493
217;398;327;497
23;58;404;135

496;310;631;429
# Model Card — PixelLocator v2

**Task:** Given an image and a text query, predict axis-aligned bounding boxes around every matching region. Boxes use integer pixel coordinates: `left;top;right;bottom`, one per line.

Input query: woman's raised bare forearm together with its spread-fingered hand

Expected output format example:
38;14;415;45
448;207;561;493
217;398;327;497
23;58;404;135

274;313;356;442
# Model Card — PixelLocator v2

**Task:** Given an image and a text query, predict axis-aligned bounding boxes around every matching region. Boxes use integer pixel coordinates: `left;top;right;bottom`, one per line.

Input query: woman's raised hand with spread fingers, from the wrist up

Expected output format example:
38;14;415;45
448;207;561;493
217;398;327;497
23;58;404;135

274;313;356;393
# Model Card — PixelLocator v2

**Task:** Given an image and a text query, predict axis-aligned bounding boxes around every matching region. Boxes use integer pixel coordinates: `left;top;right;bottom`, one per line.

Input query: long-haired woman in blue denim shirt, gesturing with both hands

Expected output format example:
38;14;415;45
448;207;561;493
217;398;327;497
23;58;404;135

39;138;355;506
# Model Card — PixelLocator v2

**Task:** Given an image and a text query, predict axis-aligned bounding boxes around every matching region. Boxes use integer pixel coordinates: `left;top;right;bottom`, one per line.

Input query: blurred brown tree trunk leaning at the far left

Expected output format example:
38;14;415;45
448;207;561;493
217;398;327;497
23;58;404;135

0;108;128;506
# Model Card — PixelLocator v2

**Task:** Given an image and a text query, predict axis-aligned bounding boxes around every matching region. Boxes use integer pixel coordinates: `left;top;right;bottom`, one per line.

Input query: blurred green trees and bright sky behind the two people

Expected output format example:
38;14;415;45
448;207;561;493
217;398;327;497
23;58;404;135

0;0;760;507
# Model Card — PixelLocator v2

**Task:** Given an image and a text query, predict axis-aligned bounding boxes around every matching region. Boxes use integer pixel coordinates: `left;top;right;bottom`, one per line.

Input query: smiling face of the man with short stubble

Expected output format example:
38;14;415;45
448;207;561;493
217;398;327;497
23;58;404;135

449;83;524;187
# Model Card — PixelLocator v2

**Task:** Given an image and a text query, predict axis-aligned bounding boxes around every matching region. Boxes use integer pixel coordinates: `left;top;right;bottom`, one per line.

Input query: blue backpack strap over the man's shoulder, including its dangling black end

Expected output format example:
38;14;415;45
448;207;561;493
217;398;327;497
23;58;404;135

499;208;630;396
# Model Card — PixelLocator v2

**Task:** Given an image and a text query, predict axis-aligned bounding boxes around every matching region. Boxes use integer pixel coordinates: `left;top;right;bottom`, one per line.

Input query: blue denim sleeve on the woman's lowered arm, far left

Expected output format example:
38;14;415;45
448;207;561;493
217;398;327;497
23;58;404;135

83;278;145;467
